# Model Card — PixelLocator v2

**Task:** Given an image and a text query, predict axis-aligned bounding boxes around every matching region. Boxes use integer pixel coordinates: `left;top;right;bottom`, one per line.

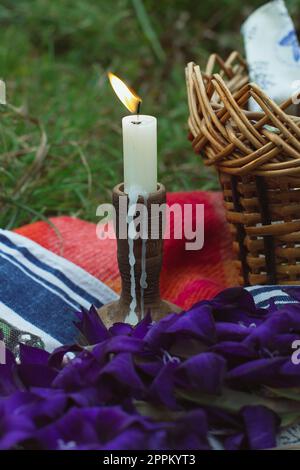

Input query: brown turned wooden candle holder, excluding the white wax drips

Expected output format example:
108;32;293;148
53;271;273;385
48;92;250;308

98;183;180;327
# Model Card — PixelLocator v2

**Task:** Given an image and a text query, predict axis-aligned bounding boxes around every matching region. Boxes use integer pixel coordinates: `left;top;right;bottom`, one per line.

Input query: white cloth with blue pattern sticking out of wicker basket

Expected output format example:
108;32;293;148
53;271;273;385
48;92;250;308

242;0;300;114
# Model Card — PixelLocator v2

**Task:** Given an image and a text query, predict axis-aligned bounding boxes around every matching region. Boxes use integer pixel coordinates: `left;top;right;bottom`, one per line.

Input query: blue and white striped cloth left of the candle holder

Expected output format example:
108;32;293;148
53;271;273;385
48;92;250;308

0;229;118;350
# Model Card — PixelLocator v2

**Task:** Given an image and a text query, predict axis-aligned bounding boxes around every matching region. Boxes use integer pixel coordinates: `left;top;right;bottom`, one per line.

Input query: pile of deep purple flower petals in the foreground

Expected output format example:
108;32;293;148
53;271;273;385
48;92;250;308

0;288;300;450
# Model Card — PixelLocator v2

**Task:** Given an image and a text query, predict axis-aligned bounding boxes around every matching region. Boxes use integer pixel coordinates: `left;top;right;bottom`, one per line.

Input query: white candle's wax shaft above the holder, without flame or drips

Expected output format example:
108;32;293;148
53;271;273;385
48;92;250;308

122;115;157;195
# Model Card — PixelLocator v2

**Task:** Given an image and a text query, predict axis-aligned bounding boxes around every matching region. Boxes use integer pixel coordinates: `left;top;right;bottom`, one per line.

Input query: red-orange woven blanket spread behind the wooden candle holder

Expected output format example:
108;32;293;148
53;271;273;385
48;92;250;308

16;191;237;309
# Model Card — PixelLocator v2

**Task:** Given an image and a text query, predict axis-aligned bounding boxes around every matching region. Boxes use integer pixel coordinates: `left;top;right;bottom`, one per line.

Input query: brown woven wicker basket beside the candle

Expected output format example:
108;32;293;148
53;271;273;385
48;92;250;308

186;52;300;285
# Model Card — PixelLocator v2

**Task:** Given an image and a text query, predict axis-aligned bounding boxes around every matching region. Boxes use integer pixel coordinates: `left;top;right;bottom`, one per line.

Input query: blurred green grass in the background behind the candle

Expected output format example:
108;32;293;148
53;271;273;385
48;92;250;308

0;0;299;228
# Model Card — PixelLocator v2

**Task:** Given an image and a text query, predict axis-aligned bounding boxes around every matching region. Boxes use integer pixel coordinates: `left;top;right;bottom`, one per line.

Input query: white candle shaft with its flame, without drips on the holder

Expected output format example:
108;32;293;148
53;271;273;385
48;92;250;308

108;73;157;195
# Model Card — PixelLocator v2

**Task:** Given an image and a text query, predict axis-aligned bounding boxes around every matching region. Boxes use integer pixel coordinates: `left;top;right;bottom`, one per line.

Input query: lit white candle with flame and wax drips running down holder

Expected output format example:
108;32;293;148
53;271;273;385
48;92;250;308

108;73;157;325
